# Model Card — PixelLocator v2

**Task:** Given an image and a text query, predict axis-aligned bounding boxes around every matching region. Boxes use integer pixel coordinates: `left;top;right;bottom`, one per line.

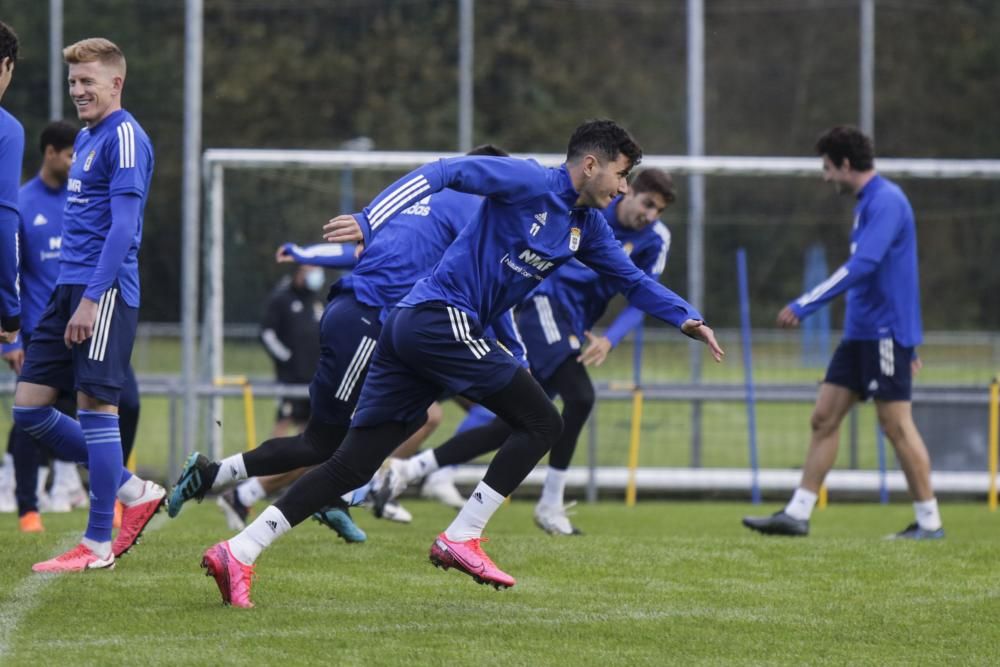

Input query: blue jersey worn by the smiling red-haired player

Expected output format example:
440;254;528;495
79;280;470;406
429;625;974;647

59;109;153;308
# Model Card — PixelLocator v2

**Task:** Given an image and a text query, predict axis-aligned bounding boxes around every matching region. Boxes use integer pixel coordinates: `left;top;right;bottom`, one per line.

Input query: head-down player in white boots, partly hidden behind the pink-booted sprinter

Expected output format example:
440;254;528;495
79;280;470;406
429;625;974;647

375;169;676;535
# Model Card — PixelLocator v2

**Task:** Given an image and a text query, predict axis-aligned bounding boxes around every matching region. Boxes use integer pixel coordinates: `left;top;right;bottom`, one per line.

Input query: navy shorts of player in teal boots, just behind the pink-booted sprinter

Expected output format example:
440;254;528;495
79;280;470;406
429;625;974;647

309;290;382;426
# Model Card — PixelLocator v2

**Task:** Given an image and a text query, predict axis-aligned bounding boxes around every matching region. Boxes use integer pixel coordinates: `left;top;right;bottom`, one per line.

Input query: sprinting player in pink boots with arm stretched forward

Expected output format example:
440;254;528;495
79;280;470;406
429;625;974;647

202;120;722;606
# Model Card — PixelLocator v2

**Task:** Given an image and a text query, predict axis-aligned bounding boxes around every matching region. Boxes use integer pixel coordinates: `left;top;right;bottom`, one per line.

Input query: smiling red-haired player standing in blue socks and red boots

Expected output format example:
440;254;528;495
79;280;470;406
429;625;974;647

14;38;166;572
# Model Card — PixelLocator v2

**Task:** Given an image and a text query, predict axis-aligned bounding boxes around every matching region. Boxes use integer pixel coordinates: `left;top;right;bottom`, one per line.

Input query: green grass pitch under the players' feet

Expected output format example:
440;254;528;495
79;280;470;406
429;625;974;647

0;500;1000;666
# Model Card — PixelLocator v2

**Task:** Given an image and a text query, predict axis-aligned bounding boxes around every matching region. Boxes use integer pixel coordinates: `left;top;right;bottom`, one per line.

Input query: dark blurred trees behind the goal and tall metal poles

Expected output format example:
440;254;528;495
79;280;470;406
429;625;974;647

3;0;1000;329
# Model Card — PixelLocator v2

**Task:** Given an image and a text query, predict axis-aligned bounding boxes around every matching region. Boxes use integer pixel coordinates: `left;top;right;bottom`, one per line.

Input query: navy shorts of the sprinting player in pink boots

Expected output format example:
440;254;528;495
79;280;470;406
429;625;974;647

351;302;520;427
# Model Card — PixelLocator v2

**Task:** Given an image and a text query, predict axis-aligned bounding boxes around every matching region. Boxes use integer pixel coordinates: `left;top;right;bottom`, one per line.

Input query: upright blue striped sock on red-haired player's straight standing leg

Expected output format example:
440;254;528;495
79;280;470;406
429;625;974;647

78;410;124;553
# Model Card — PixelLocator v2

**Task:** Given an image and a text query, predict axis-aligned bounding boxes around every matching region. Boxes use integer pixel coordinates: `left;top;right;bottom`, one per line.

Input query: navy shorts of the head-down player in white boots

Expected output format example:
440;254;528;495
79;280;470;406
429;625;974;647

517;294;581;386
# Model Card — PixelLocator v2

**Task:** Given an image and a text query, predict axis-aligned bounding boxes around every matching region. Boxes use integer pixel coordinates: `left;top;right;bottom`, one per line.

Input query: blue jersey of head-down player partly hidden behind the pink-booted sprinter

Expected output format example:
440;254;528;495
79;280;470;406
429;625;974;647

532;197;670;345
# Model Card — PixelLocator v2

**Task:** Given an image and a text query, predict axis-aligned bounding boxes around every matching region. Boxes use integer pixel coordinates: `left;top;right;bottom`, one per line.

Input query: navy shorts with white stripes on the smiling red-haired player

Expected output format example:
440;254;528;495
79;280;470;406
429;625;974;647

18;283;139;405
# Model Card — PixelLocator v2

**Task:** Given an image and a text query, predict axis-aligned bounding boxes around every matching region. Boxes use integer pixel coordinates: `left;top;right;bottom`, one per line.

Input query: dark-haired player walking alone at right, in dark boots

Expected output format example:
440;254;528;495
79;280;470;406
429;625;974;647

743;126;944;540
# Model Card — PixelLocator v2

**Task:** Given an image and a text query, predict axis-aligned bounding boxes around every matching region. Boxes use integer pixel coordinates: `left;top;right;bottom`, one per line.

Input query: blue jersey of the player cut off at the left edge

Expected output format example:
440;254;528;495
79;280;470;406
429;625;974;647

0;109;24;330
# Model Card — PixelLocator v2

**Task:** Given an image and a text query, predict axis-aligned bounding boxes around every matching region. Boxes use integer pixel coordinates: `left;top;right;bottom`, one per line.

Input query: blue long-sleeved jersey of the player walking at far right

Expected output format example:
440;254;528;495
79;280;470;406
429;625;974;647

789;175;923;347
